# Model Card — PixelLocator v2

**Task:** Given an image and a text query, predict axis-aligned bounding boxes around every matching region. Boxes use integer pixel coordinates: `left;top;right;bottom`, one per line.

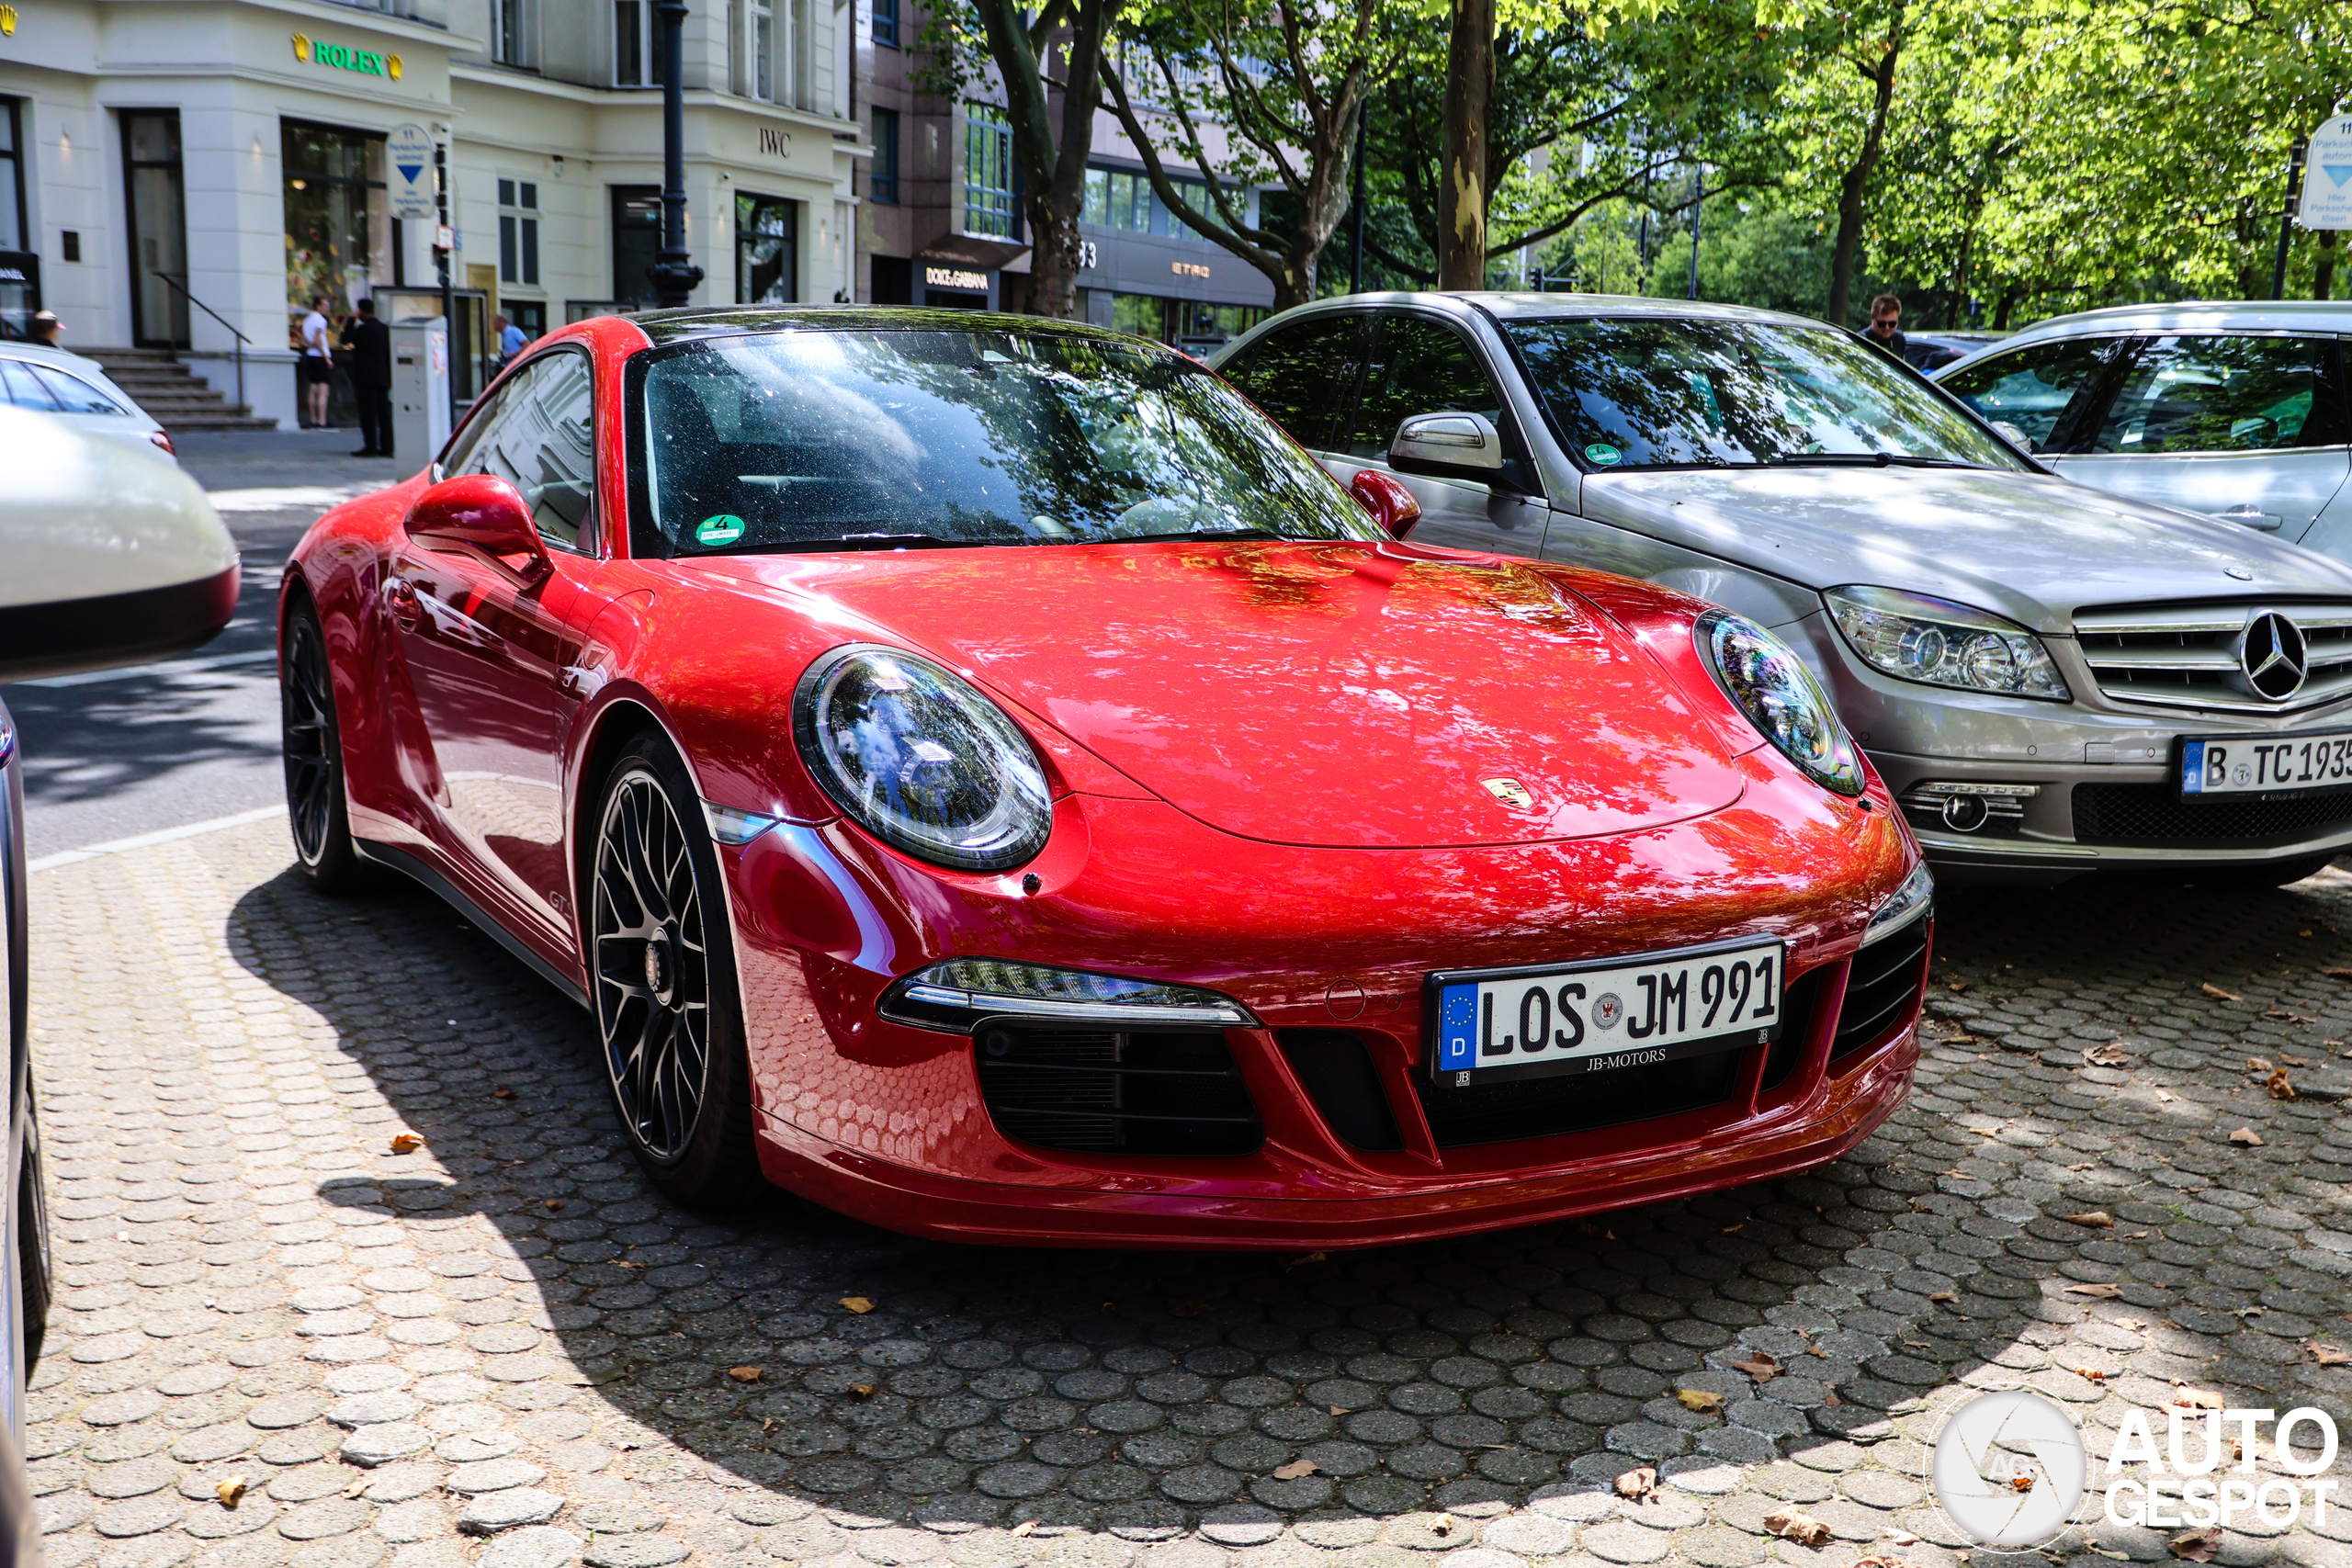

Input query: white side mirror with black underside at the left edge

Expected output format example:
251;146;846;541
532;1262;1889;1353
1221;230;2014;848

0;407;238;682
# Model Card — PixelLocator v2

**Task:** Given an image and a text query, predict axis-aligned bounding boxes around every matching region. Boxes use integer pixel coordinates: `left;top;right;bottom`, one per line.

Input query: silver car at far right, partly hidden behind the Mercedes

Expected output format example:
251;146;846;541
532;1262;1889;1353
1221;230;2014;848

1936;303;2352;559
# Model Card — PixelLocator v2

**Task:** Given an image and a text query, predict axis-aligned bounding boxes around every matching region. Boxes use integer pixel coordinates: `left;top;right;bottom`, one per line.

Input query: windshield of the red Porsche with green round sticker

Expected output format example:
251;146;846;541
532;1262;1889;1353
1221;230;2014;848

639;329;1383;555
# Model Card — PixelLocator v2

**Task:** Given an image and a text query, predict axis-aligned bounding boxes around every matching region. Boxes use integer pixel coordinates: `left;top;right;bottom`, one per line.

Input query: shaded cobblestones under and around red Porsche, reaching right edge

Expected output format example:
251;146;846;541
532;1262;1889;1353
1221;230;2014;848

228;872;2352;1565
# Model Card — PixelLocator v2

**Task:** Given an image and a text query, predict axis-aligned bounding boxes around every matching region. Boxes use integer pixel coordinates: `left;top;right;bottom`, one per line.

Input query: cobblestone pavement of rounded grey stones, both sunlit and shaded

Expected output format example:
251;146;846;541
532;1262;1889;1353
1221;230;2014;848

14;823;2352;1568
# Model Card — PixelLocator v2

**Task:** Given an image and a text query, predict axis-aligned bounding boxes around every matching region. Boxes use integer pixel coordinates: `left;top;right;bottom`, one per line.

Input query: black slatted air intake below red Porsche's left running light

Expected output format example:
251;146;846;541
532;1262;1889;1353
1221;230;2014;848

974;1025;1265;1156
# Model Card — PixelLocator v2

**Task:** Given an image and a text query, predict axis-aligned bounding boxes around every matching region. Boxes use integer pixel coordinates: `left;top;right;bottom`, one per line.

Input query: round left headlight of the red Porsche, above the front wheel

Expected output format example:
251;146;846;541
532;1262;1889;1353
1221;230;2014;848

793;644;1054;872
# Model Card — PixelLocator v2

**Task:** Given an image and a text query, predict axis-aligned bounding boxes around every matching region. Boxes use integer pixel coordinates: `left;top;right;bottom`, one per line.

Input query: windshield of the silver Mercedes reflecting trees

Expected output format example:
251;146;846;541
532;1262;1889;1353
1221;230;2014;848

1508;317;2023;470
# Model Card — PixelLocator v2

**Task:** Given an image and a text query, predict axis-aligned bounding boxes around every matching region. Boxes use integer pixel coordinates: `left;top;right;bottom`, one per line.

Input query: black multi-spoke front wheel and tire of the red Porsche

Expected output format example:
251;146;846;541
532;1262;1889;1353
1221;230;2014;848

585;733;764;1208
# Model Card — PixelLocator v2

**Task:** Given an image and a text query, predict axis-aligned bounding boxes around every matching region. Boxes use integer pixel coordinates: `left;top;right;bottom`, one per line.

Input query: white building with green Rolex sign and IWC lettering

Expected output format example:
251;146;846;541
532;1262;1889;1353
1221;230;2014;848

0;0;868;423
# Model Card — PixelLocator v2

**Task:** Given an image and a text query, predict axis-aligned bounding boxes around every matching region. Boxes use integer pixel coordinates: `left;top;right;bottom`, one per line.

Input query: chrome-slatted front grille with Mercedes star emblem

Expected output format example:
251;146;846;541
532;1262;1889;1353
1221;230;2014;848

2075;602;2352;712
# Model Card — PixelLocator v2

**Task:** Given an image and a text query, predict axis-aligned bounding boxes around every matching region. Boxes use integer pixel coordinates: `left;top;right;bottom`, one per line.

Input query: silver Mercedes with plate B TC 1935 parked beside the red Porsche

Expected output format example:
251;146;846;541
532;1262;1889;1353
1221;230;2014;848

1214;294;2352;882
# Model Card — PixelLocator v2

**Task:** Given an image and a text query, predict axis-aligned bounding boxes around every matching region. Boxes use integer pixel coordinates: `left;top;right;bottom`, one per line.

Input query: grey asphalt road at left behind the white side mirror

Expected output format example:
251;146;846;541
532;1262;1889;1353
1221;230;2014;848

0;430;404;861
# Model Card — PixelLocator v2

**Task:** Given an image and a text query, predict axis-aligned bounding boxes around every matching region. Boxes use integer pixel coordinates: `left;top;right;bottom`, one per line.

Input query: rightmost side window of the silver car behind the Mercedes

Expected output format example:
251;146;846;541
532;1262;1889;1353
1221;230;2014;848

2091;336;2347;454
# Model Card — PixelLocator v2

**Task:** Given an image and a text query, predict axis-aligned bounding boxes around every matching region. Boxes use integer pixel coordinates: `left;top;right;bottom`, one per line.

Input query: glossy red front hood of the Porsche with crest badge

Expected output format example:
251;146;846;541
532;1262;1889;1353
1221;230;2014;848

706;541;1740;849
